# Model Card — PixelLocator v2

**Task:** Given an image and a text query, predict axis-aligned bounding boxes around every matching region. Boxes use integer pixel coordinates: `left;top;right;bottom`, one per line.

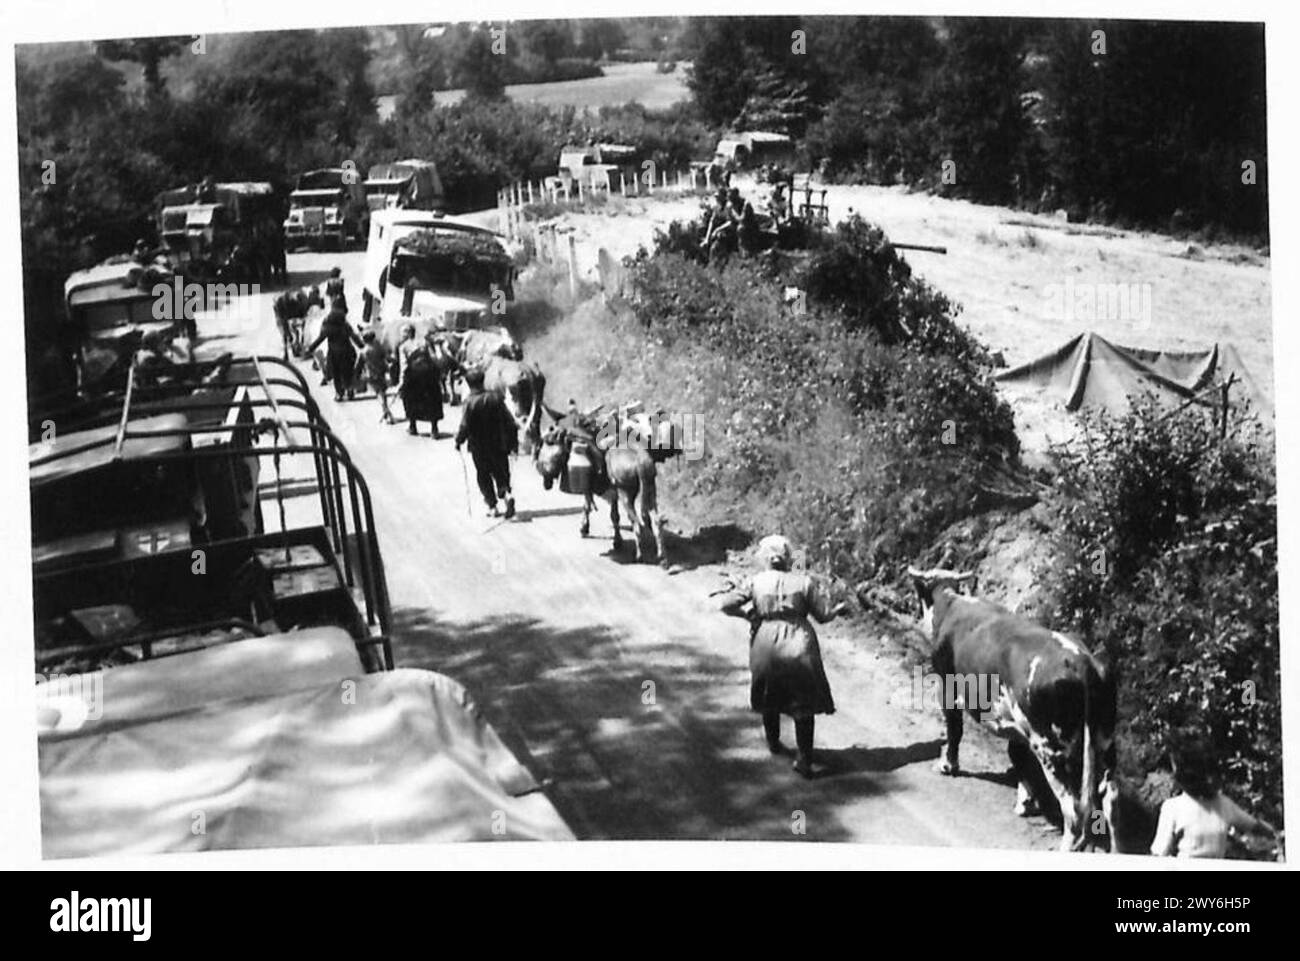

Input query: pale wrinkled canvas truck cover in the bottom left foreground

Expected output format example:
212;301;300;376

39;671;573;858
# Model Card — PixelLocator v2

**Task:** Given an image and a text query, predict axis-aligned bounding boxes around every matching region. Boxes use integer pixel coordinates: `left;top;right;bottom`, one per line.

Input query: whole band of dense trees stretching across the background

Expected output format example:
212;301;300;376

17;17;1268;395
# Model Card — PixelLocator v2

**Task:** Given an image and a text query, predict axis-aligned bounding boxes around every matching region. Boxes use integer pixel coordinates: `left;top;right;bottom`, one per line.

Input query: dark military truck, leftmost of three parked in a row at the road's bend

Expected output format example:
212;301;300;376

157;179;283;283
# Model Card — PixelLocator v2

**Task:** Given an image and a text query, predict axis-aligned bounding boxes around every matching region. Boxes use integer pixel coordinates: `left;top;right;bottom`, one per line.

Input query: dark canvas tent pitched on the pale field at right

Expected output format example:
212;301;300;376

996;333;1273;419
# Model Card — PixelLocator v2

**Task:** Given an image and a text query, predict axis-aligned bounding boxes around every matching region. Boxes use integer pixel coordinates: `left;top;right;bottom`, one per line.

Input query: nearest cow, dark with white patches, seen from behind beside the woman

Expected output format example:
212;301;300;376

909;568;1115;850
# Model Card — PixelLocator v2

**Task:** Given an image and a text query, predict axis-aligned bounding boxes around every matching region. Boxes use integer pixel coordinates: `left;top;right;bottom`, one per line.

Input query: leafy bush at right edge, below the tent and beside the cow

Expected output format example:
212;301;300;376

1048;402;1282;824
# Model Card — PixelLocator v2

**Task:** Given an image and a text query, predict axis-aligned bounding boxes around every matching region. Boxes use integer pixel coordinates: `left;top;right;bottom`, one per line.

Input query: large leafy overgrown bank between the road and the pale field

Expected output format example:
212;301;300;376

524;218;1018;581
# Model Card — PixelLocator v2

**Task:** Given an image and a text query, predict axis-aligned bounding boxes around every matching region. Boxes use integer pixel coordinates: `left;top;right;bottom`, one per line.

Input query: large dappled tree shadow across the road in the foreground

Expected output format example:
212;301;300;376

393;607;904;841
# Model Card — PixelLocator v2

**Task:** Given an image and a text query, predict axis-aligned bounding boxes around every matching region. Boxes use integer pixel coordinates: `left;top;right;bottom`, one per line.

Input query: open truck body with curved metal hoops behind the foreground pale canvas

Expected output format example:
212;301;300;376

30;356;393;671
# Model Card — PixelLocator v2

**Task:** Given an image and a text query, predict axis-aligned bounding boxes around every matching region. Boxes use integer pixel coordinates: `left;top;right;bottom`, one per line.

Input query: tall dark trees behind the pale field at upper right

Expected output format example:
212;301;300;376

688;17;1268;239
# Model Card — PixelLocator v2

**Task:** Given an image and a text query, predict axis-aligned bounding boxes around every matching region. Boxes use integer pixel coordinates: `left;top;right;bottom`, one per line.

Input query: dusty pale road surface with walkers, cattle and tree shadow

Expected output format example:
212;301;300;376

200;252;1058;858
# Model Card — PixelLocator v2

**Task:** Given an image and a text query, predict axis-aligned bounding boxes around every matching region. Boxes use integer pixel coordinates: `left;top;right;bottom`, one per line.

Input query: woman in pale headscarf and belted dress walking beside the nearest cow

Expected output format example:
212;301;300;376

720;534;848;778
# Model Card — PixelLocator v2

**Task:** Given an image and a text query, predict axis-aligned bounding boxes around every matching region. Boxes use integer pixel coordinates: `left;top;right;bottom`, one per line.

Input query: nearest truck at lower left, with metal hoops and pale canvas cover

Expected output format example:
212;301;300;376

29;356;572;858
